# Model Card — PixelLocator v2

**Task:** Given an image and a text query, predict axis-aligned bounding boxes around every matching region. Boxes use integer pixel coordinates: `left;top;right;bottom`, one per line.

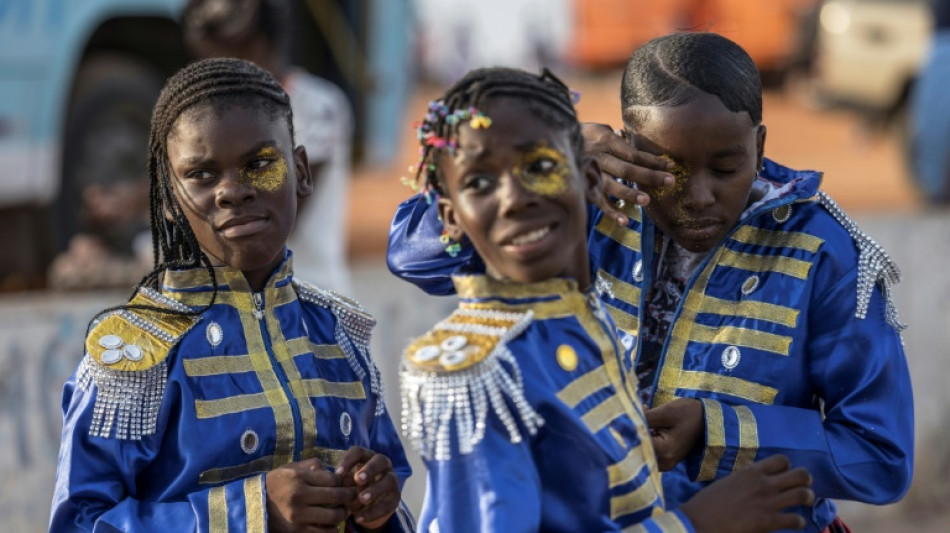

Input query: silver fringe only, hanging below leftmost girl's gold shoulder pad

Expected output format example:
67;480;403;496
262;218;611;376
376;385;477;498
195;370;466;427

76;354;168;440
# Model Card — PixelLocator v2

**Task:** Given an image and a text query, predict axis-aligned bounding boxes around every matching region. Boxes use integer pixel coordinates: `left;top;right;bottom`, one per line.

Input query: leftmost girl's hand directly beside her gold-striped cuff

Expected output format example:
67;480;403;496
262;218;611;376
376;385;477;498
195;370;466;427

264;459;356;533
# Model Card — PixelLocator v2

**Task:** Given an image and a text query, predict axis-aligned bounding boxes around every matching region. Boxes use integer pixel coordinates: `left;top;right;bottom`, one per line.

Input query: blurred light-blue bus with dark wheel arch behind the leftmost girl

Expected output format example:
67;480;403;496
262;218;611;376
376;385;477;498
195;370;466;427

0;0;409;291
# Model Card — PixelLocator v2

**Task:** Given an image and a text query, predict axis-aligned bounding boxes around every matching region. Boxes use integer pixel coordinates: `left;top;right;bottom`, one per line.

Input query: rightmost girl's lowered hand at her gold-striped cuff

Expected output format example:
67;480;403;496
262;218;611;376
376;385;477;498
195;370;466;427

644;398;705;472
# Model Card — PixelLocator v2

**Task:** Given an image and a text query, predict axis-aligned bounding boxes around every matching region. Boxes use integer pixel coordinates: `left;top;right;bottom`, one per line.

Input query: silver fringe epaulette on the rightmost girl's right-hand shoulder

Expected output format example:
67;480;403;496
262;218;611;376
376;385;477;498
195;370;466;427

818;191;907;331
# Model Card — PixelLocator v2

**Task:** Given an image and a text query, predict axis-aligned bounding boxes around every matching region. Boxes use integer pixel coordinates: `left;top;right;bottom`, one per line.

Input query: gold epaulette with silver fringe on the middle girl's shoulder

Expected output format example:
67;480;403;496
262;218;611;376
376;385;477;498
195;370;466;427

400;309;544;461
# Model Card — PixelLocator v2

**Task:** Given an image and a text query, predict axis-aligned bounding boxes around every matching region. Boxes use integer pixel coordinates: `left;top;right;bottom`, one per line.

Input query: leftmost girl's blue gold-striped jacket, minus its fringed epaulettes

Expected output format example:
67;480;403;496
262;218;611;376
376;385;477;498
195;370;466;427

50;255;410;532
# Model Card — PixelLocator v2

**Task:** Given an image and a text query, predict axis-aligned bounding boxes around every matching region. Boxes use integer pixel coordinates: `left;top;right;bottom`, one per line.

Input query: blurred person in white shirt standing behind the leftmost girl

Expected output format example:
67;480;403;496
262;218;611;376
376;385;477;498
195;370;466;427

182;0;354;293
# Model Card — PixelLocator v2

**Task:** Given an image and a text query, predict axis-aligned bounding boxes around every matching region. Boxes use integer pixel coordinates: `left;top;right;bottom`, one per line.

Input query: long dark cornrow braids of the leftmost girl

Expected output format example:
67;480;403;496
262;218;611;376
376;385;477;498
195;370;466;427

90;58;294;324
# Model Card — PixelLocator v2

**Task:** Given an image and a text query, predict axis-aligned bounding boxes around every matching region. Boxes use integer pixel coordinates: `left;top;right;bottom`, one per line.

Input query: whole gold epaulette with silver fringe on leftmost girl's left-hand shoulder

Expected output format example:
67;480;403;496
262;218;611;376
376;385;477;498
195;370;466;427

76;289;198;440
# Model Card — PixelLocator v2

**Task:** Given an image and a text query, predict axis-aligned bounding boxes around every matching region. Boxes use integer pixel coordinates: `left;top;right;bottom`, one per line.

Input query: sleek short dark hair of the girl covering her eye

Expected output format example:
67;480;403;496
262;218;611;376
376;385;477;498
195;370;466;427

620;32;762;129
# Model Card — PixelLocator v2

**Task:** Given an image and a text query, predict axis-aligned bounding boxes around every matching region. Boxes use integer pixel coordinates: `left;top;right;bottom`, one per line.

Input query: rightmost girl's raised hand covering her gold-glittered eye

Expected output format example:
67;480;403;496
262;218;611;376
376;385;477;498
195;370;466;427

581;122;673;224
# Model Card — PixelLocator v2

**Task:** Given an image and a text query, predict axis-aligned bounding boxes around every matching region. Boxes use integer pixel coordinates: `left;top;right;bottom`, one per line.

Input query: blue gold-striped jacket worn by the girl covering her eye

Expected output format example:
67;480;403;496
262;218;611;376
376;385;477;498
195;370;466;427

387;160;914;531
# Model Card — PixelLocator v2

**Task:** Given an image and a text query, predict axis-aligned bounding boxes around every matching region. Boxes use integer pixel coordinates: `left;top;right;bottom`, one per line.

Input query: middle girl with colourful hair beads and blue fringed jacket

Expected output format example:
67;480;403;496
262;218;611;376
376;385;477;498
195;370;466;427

402;64;813;533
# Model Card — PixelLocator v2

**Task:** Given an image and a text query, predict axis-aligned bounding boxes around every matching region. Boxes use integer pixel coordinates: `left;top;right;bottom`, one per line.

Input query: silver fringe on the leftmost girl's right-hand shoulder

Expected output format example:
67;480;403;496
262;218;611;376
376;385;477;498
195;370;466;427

293;279;386;416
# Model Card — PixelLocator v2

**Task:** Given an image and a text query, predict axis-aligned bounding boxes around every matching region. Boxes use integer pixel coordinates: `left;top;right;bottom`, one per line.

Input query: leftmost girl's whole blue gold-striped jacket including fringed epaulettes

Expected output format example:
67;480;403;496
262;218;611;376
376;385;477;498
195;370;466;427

50;252;413;533
